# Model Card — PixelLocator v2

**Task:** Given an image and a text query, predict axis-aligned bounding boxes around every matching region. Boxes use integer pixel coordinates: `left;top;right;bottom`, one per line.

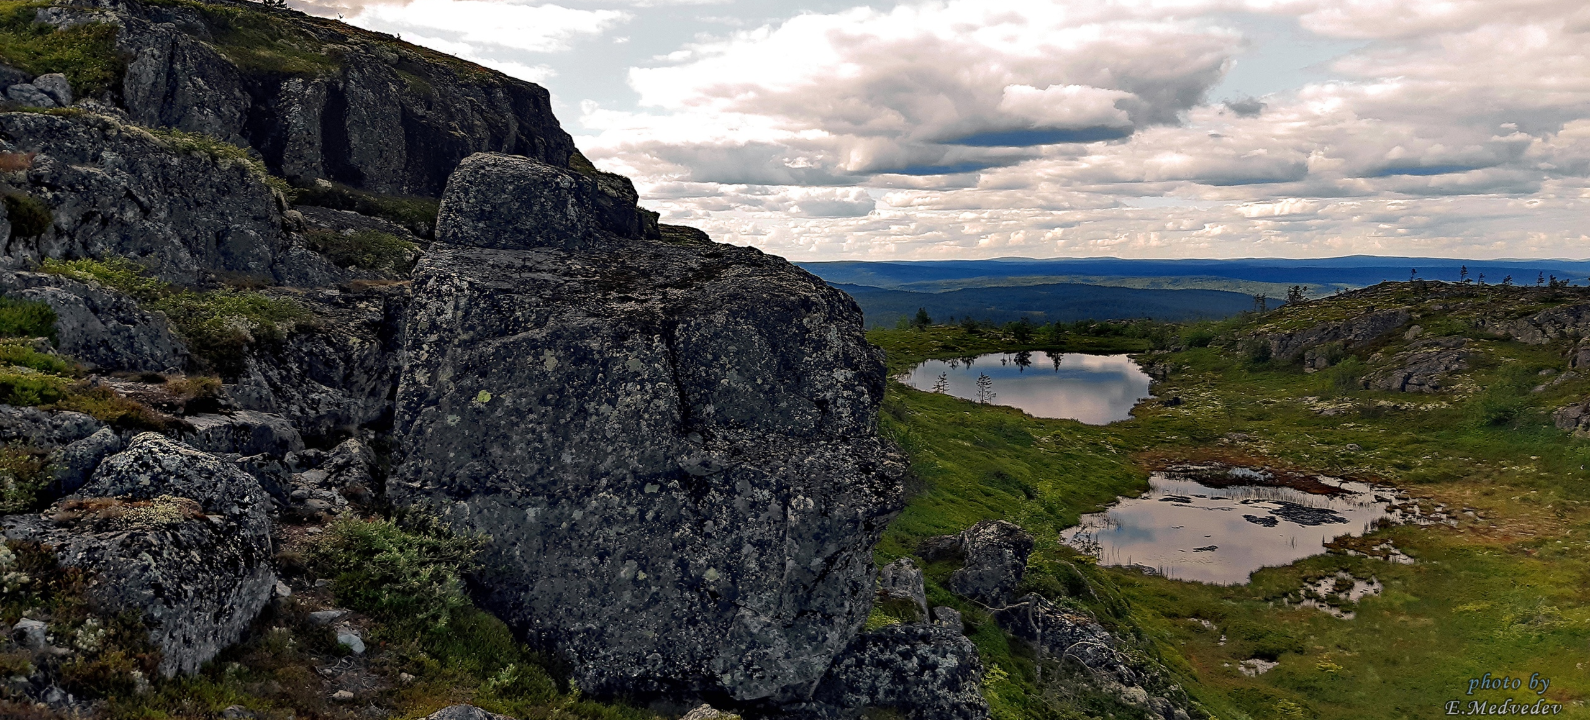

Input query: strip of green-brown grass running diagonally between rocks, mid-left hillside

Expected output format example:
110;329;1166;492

40;259;315;375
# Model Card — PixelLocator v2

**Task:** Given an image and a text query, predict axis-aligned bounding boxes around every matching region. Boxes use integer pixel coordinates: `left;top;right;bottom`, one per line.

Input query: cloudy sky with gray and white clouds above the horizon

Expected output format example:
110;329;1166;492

289;0;1590;261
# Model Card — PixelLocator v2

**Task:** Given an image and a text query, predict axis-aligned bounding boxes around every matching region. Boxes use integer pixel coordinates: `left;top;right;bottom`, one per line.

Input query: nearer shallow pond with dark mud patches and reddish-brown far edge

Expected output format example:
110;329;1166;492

1061;467;1409;585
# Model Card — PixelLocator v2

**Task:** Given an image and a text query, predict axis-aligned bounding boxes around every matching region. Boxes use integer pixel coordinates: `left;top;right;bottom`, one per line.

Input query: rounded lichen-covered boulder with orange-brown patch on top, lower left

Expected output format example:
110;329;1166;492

3;432;275;677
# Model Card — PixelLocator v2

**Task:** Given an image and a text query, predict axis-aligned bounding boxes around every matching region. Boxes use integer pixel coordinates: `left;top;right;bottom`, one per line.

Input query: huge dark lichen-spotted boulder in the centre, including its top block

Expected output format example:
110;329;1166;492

388;150;903;703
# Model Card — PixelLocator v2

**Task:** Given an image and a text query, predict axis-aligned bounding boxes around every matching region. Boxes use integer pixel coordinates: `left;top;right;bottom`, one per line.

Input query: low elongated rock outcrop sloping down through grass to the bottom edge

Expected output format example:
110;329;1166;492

994;594;1189;720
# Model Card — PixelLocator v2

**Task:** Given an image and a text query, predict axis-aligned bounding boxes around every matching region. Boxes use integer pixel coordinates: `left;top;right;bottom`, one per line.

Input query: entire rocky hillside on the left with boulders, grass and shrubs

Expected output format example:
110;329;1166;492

0;0;1000;720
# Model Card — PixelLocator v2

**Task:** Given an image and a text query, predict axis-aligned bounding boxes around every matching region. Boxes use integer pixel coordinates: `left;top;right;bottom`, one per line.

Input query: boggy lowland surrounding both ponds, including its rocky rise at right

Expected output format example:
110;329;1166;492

870;283;1590;720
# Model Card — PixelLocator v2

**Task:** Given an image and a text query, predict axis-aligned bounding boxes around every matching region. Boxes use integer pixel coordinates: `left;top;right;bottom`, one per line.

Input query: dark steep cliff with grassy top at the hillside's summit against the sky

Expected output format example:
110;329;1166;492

80;0;574;197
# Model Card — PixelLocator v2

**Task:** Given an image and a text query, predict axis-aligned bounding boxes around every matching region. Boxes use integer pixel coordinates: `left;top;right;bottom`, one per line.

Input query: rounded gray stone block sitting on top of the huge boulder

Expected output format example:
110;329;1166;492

436;153;644;251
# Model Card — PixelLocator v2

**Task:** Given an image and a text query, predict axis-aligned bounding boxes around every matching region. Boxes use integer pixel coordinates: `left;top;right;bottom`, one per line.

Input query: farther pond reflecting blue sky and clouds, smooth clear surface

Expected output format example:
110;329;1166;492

900;351;1150;424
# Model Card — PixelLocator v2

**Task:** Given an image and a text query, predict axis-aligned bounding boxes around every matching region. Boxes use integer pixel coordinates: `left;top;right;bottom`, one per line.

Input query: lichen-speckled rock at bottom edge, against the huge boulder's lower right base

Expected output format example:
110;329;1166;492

801;625;989;720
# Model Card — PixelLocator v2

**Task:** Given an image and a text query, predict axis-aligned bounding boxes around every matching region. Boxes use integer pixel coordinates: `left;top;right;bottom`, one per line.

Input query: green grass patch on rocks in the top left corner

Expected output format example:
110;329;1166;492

0;2;126;97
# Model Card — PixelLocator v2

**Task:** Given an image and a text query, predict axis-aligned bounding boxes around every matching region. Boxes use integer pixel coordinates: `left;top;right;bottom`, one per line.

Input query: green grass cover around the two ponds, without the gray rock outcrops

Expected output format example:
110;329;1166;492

870;291;1590;718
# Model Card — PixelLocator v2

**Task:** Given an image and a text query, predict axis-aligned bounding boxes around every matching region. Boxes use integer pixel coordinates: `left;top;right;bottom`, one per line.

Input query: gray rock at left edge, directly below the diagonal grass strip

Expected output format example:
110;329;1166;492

0;272;188;372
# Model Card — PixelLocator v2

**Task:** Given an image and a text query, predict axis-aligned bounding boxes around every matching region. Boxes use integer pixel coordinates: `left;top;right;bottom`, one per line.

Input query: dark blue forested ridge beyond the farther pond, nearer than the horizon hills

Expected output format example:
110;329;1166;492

835;283;1278;327
